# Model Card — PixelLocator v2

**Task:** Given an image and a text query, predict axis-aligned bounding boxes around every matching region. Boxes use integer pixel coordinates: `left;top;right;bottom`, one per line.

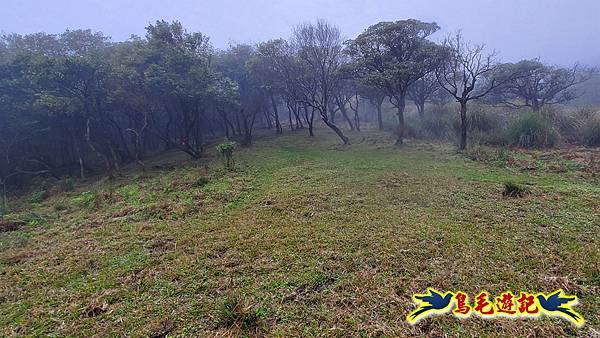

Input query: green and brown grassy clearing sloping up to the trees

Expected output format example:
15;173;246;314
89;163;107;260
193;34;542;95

0;130;600;337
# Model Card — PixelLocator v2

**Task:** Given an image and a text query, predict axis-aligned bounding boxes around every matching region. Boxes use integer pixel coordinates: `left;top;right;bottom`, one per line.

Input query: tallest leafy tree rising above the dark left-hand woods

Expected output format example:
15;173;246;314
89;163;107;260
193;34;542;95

142;21;214;158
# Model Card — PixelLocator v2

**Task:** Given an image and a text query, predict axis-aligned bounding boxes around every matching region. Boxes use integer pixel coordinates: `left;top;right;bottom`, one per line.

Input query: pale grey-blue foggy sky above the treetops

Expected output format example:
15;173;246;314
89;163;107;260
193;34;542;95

0;0;600;65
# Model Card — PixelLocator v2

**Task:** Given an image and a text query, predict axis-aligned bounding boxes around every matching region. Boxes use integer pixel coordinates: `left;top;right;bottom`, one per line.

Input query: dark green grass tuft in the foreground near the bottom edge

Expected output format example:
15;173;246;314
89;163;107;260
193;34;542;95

216;295;263;331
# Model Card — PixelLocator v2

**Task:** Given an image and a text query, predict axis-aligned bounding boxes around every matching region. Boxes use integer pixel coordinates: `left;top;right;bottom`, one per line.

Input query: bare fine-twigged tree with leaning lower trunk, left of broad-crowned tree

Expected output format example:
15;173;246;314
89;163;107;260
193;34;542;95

292;20;349;144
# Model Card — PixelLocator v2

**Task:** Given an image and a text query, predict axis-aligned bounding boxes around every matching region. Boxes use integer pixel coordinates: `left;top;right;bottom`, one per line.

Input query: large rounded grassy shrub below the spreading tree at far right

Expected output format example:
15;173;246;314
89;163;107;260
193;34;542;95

506;113;559;148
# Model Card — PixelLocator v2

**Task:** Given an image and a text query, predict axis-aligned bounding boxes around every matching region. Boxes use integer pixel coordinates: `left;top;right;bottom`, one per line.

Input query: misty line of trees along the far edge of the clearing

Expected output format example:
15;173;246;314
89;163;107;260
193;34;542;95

0;20;597;203
